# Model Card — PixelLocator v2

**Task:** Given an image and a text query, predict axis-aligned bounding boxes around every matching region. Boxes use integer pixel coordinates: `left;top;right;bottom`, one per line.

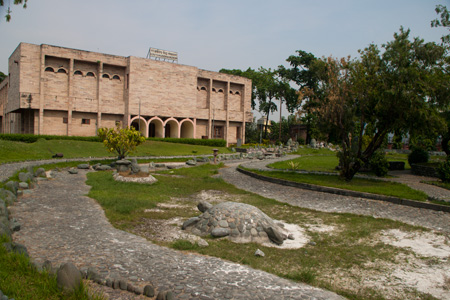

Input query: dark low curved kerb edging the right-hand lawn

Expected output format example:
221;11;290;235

236;167;450;212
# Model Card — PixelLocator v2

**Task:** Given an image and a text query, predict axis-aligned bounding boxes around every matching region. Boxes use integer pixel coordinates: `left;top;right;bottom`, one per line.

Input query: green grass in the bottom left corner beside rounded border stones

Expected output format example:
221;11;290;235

0;236;104;300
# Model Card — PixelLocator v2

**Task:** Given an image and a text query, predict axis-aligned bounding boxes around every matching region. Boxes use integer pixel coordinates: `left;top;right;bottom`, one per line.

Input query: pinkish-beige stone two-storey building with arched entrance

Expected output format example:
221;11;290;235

0;43;253;144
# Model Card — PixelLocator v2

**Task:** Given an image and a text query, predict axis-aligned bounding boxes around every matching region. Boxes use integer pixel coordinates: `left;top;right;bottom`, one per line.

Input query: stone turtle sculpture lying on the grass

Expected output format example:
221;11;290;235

182;201;292;245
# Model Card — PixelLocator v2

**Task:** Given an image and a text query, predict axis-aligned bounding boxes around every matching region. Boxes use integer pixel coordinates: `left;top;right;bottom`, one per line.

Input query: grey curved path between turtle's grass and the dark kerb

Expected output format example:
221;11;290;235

220;156;450;232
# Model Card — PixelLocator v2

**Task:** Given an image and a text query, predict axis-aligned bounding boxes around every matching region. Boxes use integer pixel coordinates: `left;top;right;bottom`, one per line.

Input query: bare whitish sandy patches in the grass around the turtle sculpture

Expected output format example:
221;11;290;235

132;191;450;299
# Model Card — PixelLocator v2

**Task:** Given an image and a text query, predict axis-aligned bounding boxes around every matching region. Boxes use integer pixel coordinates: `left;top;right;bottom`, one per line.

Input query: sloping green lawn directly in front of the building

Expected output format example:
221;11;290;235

0;139;230;163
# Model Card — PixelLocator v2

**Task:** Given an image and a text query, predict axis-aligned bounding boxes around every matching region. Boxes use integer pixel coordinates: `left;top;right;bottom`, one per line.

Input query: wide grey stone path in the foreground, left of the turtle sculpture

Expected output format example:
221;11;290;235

12;171;343;299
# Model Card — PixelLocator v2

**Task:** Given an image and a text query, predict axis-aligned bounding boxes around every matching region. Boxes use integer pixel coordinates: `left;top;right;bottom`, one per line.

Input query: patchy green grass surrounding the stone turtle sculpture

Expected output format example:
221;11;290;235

84;164;432;299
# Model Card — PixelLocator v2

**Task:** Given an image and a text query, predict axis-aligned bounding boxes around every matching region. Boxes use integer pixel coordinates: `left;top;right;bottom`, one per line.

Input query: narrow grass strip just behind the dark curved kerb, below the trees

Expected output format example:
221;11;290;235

244;168;428;201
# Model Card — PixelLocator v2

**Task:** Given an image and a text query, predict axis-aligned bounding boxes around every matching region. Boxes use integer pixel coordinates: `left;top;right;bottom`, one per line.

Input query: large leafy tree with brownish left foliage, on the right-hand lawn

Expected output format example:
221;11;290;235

304;28;450;180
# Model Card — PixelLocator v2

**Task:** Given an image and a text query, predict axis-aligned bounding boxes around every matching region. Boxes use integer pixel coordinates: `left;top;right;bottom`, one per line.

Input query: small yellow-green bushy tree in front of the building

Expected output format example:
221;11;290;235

98;125;145;159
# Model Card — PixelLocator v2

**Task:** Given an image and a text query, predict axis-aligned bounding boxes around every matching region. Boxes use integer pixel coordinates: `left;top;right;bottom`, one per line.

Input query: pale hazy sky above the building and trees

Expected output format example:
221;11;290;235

0;0;450;117
